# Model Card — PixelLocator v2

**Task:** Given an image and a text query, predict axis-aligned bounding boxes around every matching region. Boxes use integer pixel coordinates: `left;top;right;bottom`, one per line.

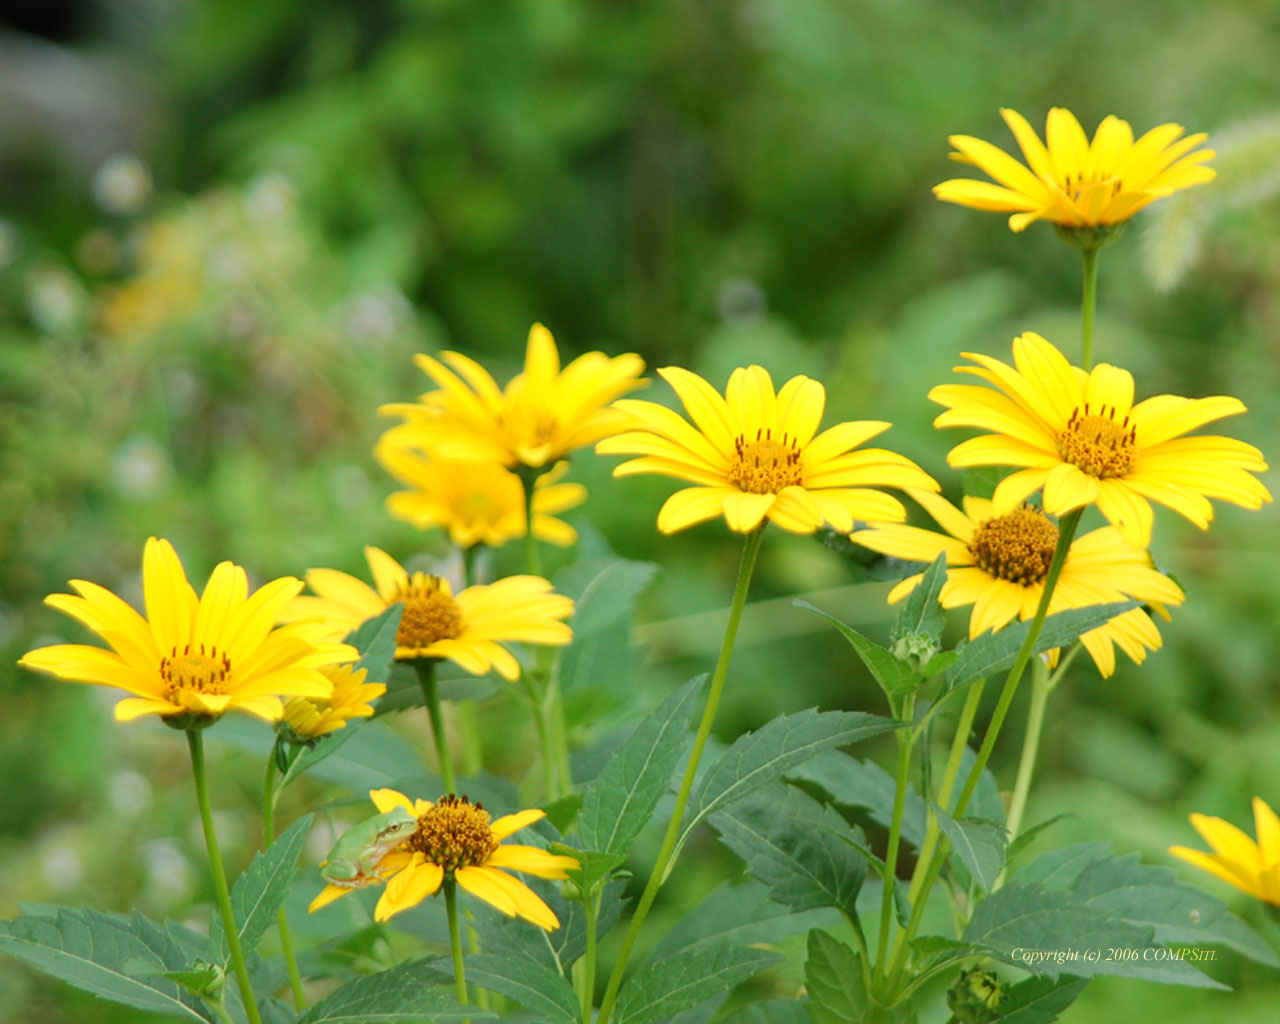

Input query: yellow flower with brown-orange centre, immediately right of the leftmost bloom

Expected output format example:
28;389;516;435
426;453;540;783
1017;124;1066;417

285;548;573;680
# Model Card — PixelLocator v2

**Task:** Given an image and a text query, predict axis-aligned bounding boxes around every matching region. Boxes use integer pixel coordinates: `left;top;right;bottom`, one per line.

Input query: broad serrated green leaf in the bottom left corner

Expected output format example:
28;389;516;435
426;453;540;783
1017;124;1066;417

0;908;212;1021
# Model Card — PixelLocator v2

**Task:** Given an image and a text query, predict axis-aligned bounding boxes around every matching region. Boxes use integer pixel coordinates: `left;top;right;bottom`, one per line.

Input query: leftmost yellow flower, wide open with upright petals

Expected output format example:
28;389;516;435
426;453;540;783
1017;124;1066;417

19;538;360;724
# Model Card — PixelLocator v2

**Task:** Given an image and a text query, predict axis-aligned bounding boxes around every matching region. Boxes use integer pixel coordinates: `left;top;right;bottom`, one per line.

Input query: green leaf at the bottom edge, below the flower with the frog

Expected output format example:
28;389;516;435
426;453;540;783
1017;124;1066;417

297;960;494;1024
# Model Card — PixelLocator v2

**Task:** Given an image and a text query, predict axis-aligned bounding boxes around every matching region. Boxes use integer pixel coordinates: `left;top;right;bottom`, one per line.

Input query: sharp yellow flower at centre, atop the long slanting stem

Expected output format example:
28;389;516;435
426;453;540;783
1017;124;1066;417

595;366;938;534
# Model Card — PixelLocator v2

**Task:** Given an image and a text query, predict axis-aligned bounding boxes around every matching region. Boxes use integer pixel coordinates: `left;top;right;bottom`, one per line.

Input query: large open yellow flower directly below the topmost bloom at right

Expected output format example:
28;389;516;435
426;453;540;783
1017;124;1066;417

929;332;1271;548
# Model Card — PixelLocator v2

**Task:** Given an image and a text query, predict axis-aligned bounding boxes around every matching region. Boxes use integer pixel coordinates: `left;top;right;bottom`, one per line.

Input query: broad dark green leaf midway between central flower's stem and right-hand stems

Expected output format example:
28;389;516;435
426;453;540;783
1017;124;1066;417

710;785;867;918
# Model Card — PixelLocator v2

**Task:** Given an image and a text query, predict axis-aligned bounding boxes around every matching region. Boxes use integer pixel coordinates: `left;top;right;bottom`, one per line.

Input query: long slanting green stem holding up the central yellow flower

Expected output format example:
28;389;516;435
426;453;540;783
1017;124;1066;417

596;524;765;1024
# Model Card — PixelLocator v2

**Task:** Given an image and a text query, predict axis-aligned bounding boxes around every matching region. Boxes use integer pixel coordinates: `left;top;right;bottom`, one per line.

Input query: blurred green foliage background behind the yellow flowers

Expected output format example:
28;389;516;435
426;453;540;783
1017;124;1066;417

0;0;1280;1024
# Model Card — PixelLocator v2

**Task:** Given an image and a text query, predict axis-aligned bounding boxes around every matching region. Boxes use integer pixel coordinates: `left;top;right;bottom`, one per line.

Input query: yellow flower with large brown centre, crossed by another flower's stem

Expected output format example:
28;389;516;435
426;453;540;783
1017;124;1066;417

852;490;1183;676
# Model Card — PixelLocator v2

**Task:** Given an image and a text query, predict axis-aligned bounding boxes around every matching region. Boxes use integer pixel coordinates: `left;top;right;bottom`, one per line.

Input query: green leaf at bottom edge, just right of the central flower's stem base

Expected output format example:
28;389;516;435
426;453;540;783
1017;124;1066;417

613;946;782;1024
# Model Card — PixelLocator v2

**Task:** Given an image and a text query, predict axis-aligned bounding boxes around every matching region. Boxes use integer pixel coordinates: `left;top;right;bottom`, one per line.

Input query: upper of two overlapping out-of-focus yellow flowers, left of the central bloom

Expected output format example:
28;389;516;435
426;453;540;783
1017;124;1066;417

379;324;645;468
